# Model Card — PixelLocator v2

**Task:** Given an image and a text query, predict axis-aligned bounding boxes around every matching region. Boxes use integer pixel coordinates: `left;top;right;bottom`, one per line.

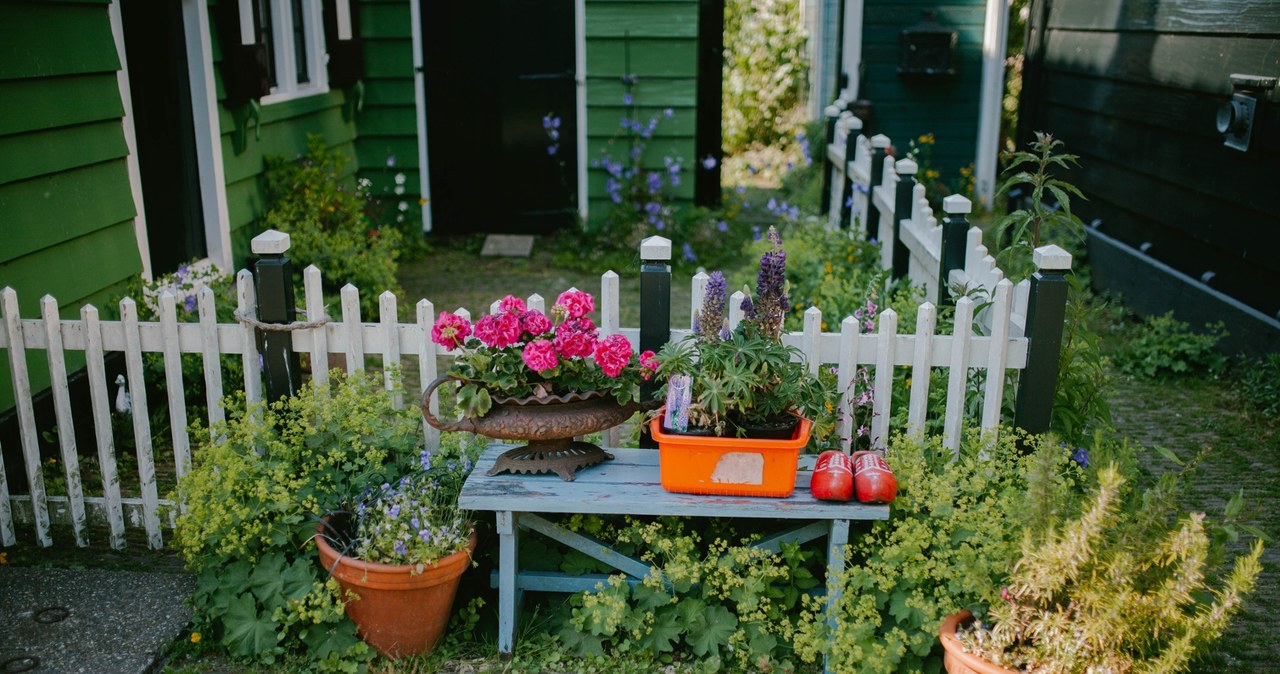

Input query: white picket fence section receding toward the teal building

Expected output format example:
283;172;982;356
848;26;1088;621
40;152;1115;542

826;113;1030;335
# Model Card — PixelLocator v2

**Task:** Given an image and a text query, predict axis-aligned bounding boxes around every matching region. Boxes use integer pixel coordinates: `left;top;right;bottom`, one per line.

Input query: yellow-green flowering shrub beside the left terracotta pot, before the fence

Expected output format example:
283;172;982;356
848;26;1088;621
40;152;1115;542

170;371;460;671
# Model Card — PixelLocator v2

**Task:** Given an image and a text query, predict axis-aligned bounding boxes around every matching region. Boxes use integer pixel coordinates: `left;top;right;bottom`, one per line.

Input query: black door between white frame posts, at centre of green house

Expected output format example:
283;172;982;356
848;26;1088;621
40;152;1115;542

422;0;577;234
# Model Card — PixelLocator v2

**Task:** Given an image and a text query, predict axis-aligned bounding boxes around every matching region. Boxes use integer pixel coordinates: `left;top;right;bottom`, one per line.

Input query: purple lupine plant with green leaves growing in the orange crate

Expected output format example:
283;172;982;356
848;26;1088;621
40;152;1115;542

658;228;826;435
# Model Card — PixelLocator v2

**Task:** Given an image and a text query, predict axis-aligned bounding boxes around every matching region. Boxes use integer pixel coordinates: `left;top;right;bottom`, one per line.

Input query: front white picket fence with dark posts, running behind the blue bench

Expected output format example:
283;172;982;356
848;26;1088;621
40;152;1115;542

0;228;1070;549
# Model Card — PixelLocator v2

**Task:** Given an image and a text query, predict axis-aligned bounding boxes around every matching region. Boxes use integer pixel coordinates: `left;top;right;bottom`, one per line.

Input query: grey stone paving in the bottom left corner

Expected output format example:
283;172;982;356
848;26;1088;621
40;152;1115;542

0;567;196;674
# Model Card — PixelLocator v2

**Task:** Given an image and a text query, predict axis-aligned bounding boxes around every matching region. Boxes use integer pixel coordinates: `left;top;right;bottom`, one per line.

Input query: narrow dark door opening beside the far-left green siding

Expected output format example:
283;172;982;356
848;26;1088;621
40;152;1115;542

120;0;209;276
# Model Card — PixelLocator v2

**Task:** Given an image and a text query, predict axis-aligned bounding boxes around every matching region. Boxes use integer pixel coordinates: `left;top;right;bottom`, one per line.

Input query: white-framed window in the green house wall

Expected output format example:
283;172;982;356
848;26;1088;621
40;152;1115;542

253;0;329;104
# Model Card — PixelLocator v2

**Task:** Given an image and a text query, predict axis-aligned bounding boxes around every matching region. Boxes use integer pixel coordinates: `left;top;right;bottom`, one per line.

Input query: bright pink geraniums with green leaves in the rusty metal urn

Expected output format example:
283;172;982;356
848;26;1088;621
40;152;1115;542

431;290;657;417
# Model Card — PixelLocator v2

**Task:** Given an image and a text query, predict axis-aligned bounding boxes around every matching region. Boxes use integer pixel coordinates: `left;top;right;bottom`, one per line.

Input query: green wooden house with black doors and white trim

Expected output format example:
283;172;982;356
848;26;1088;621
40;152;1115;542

0;0;723;427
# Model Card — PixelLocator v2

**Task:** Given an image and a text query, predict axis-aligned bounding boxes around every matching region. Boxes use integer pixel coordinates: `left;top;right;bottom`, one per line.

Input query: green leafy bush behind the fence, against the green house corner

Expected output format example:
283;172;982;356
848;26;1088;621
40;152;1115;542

262;136;402;317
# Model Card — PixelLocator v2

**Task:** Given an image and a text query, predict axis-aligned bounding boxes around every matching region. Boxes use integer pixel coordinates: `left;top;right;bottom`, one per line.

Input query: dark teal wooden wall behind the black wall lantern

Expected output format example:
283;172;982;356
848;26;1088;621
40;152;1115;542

859;0;986;177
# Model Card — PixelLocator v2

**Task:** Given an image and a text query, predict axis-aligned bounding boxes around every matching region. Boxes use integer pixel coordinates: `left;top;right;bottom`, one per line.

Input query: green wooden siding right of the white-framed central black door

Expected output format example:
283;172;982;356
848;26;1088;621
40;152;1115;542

586;0;698;221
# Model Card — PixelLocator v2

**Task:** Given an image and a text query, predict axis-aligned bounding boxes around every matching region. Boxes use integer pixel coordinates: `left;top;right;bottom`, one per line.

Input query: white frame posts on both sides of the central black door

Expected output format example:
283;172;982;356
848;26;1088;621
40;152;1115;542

408;0;589;231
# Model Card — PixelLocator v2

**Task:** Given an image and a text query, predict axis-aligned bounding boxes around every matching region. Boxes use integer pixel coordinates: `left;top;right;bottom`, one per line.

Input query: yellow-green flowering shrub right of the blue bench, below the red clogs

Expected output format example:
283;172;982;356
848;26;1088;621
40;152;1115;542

796;432;1082;674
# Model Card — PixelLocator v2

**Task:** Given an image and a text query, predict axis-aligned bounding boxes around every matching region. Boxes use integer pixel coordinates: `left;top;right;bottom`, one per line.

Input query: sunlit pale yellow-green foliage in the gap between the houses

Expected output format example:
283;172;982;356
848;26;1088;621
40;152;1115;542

721;0;809;155
